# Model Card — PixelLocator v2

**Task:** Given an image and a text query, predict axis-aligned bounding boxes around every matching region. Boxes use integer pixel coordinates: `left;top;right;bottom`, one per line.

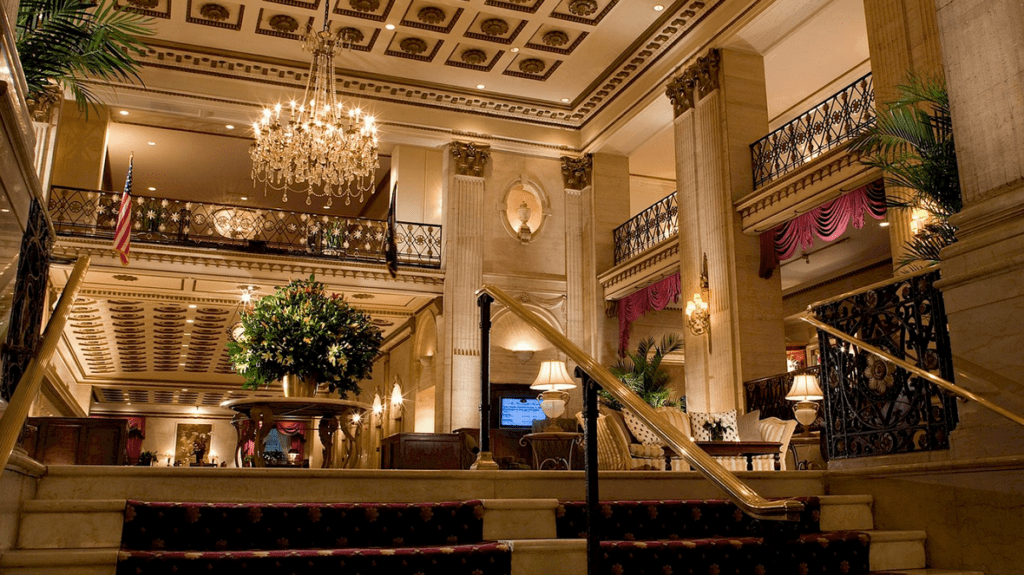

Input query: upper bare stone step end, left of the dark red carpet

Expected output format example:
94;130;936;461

17;499;125;549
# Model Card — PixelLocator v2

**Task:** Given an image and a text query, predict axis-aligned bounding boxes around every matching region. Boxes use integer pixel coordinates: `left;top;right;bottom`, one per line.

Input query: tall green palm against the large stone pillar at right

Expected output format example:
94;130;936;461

850;77;963;267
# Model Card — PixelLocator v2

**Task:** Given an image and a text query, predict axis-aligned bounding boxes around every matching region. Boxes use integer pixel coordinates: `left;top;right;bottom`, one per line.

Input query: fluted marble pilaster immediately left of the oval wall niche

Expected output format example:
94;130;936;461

443;142;490;432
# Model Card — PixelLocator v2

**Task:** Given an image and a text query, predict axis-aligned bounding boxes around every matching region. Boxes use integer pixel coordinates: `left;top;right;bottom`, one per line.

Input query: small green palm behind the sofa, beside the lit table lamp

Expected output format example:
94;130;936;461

601;334;683;409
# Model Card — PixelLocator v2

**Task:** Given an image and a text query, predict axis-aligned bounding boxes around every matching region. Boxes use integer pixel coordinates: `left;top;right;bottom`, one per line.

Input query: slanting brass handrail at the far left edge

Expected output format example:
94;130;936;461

0;256;90;471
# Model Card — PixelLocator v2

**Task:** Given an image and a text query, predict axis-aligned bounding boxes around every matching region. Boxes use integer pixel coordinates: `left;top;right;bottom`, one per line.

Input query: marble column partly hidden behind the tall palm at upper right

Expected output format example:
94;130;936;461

864;0;942;273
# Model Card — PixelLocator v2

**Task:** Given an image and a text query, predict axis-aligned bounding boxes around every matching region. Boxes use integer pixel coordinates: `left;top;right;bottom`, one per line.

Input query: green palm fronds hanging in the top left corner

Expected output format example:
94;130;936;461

15;0;153;112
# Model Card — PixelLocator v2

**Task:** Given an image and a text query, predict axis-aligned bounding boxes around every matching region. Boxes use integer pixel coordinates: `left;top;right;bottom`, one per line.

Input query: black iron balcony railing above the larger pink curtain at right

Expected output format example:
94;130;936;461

751;74;874;188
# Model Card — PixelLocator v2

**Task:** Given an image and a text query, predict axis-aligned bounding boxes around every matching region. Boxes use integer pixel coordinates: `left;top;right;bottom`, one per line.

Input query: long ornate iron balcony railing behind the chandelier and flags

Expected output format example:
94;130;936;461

49;186;441;268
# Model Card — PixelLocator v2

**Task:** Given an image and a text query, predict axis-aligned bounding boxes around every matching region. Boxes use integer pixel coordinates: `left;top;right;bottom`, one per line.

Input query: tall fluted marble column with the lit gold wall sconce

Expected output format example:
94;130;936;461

668;50;785;411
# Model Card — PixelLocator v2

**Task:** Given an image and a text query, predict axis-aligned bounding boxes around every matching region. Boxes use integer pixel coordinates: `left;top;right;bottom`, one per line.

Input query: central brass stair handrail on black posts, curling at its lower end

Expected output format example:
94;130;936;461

476;284;804;521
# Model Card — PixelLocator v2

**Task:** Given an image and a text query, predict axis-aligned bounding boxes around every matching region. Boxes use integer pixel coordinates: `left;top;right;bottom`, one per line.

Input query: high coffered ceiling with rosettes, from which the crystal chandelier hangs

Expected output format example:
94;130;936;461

110;0;737;127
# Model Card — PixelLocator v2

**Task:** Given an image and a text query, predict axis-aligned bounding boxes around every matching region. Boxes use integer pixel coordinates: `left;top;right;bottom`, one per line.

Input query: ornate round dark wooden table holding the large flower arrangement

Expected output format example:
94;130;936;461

220;397;370;469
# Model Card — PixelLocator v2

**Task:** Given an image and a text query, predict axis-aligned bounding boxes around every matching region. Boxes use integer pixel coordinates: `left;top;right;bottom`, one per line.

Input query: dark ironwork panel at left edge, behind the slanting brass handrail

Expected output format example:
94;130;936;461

0;200;53;400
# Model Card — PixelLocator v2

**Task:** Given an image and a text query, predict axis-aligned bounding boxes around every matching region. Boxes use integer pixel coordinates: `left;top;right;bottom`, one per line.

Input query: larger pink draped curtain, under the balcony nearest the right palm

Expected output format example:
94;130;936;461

759;182;886;279
